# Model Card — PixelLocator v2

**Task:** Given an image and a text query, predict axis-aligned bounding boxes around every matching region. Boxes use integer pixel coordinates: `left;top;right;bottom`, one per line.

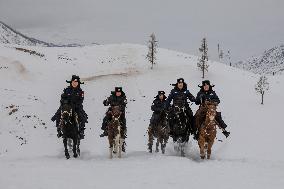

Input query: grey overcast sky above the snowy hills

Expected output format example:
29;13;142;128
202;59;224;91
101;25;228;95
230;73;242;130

0;0;284;61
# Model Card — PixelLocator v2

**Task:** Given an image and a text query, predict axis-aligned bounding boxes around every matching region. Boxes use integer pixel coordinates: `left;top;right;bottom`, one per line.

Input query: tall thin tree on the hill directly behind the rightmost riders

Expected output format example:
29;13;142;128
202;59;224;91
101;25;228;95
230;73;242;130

197;38;209;78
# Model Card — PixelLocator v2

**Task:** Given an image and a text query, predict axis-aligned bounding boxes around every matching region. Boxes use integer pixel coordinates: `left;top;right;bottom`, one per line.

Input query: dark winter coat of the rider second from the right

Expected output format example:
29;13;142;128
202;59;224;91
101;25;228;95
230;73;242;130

166;84;195;108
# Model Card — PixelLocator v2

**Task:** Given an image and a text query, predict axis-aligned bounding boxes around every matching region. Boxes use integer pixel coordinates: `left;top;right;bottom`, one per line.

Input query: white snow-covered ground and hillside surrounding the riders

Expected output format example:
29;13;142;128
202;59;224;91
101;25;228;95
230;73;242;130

0;44;284;189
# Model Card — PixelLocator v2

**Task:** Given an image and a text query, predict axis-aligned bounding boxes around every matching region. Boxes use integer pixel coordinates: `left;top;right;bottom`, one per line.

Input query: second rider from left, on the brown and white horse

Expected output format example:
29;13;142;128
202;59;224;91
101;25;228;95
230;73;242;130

100;87;127;139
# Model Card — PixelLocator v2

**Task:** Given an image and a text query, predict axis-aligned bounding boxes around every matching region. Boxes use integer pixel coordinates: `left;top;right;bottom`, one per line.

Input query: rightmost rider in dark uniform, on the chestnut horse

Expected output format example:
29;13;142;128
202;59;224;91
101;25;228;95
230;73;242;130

195;80;230;139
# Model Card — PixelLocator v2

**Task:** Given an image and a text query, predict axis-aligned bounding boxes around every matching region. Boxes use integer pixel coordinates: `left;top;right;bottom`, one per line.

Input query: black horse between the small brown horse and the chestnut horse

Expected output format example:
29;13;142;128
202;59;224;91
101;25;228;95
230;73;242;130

169;106;191;156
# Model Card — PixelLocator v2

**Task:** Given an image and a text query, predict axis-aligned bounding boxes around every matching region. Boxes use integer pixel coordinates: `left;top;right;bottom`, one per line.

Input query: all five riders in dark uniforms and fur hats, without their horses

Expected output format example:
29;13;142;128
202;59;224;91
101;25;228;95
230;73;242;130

51;75;230;151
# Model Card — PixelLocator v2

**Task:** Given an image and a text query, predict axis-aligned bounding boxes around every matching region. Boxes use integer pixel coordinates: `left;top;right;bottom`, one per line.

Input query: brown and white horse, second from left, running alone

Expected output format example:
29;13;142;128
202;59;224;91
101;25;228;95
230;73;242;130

107;106;124;159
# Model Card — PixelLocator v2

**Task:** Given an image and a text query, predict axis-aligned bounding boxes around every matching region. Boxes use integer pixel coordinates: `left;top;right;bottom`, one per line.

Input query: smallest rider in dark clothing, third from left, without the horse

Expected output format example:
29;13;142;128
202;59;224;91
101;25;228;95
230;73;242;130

149;91;167;129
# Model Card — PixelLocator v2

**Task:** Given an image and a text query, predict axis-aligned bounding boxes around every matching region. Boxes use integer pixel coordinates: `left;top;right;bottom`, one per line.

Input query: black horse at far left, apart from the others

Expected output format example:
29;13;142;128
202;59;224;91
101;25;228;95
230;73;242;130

59;101;80;159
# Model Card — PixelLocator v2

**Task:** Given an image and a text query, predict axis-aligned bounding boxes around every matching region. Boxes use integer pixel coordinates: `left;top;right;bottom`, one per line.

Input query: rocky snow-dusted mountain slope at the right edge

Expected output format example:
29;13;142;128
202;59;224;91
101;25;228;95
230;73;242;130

234;45;284;74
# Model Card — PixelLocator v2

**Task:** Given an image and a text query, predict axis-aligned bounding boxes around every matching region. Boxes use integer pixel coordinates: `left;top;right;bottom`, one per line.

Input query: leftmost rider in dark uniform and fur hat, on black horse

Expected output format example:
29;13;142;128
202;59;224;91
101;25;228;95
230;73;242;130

51;75;88;139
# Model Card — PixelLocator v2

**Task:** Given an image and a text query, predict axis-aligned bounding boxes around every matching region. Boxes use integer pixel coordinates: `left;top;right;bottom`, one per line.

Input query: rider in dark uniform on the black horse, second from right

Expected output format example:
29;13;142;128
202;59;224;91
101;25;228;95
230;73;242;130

166;78;195;134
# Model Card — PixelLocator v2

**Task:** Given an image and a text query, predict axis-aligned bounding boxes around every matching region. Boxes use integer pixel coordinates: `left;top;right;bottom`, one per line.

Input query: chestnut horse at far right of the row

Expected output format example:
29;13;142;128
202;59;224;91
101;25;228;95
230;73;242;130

198;101;218;159
